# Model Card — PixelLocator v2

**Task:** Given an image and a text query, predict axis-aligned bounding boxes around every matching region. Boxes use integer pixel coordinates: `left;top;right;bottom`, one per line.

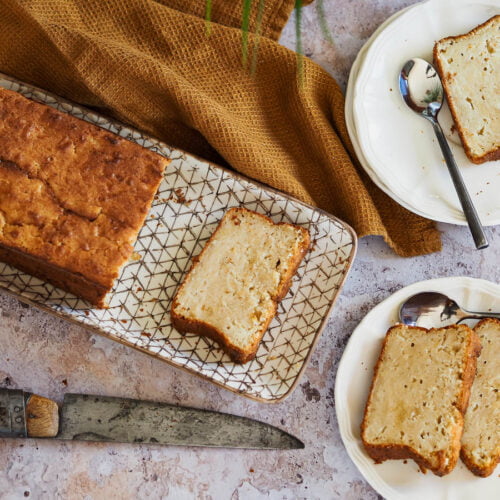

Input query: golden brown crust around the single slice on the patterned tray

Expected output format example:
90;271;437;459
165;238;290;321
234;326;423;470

170;207;310;363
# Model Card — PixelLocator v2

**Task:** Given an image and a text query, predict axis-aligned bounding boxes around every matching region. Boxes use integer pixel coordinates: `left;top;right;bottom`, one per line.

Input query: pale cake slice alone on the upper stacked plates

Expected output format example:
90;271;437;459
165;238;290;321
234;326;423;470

434;15;500;163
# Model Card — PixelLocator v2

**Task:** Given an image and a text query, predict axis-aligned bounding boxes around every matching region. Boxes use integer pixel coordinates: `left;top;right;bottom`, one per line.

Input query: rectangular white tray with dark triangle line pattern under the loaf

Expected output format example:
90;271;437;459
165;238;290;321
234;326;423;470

0;74;356;402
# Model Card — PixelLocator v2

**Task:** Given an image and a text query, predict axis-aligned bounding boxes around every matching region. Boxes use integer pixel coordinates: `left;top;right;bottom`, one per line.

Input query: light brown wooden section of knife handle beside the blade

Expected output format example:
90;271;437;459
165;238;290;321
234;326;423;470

25;394;59;437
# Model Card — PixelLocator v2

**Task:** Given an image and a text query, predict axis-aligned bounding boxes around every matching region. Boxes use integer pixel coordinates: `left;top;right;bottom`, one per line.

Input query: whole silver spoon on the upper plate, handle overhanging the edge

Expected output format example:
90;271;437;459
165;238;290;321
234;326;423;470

399;58;488;250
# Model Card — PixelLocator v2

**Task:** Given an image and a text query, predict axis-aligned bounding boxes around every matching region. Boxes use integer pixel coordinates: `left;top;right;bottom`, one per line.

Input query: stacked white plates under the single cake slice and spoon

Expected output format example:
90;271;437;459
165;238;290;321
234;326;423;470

345;0;500;226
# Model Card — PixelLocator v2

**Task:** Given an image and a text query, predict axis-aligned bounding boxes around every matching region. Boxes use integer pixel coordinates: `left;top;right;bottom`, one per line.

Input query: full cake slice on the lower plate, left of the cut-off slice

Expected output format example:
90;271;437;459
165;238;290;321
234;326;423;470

361;325;480;476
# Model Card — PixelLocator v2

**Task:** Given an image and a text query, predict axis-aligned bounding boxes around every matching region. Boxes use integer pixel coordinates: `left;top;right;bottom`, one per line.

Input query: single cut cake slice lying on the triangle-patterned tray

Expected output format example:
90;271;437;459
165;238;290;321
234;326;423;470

171;208;310;363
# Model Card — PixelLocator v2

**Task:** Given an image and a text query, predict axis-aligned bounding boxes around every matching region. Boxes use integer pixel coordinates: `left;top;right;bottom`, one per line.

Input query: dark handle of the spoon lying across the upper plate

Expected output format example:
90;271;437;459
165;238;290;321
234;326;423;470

431;120;488;250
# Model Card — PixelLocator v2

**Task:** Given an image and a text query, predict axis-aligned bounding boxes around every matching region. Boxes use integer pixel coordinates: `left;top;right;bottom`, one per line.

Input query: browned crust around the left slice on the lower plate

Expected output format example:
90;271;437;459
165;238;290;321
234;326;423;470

361;325;481;476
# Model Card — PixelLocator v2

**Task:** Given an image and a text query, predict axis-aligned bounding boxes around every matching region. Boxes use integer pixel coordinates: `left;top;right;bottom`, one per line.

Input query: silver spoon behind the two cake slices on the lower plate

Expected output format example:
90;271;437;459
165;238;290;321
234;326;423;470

399;292;500;328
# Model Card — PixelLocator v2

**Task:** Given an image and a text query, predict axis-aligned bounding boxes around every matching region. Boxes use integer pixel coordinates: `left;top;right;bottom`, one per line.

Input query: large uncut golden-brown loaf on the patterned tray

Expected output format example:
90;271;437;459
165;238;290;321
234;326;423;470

0;88;169;307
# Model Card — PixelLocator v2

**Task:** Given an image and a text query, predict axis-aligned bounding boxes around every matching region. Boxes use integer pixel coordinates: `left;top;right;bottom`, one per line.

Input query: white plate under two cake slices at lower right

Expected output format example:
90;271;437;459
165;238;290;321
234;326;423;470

335;277;500;500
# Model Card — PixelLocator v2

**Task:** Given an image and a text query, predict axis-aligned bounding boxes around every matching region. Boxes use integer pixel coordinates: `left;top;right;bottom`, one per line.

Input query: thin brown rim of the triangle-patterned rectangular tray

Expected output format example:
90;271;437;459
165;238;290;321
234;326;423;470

0;72;358;404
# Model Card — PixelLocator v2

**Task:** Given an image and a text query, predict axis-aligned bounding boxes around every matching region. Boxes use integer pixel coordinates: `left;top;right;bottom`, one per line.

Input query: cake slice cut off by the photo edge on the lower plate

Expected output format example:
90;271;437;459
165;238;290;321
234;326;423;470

460;318;500;477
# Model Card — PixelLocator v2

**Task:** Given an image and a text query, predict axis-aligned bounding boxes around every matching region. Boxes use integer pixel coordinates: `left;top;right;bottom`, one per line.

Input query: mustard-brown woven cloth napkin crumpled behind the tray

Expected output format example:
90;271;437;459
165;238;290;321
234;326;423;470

0;0;441;256
